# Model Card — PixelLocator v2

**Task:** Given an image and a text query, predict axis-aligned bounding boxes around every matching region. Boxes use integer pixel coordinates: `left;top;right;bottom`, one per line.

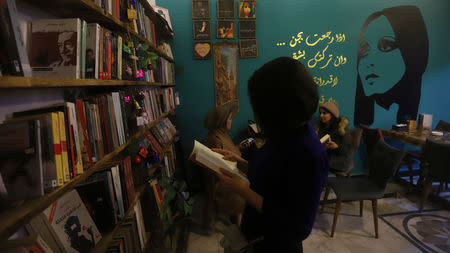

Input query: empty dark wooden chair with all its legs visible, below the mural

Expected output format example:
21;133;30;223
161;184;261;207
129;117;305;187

322;139;404;238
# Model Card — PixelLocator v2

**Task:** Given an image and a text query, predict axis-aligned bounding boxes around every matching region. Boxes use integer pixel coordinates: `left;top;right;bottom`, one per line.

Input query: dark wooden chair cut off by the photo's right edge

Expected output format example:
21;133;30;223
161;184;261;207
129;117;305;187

419;138;450;212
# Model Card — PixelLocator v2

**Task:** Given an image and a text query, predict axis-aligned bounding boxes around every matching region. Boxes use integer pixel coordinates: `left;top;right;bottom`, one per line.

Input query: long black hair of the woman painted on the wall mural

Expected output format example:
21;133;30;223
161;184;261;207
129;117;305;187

354;6;428;126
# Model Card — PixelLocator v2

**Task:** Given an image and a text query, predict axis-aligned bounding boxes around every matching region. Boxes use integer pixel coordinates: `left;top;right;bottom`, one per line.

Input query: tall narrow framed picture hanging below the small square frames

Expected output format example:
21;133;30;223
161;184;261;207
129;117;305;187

213;42;239;105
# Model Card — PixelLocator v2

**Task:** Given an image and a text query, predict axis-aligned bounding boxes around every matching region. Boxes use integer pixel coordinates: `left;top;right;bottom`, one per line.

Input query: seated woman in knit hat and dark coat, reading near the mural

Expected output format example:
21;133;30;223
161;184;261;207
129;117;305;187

314;102;352;175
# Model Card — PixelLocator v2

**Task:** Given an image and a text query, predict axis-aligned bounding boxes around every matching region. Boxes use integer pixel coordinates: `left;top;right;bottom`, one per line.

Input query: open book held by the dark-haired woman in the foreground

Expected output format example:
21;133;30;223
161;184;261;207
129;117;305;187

189;141;248;181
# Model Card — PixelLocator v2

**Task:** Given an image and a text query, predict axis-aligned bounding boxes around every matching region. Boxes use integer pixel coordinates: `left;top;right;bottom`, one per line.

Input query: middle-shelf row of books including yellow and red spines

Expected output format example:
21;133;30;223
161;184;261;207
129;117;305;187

0;88;179;200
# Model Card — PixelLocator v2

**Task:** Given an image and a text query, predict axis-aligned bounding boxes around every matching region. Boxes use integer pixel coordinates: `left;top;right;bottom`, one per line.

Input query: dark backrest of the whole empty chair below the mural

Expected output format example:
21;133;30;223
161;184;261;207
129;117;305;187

368;139;405;189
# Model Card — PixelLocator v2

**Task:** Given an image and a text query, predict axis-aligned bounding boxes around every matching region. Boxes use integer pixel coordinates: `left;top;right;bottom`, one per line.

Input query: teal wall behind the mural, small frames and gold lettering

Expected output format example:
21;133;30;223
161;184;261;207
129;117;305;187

157;0;450;172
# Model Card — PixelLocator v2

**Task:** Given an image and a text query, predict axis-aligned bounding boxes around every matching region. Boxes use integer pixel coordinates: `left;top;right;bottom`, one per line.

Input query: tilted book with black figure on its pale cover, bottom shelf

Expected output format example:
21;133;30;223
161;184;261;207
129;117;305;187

43;190;102;253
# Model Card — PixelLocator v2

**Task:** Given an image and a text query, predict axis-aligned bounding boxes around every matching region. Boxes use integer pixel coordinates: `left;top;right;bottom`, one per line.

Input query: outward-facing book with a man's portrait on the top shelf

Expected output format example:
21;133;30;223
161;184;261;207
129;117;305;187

30;18;81;78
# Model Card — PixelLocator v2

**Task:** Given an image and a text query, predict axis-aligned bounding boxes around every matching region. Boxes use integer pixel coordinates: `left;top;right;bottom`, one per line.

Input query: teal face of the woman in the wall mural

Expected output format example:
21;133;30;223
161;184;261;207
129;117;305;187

358;16;406;96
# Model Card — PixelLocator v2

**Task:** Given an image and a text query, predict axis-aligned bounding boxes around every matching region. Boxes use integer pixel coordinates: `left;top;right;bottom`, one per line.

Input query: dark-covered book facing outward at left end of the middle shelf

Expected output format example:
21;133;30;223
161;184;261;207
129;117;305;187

0;120;44;200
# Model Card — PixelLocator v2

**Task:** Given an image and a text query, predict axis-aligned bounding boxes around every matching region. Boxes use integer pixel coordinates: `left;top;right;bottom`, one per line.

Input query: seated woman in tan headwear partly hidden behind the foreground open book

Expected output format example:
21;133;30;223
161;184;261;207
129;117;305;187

203;101;245;230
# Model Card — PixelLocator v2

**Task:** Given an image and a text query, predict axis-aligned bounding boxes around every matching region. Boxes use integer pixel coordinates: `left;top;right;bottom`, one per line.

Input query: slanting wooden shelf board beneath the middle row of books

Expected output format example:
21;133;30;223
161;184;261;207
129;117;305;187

0;110;173;242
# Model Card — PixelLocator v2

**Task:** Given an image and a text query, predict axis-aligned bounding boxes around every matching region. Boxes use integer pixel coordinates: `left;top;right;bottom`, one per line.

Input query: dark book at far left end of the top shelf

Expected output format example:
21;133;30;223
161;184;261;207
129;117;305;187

0;0;31;77
